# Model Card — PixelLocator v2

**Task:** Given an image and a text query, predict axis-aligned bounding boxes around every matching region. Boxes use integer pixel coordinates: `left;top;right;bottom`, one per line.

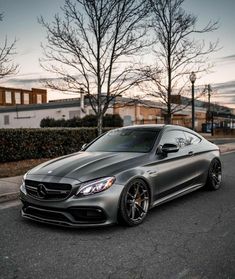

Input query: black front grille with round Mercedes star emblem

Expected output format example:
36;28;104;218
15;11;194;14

25;182;72;200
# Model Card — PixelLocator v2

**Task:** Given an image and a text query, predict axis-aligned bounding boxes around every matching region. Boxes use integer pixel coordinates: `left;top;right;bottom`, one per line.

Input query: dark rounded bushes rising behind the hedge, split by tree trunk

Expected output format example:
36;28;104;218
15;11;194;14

40;114;123;128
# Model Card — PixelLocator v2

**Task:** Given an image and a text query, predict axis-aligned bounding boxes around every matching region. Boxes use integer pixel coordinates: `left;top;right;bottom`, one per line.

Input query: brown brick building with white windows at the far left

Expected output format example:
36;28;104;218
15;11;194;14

0;87;47;106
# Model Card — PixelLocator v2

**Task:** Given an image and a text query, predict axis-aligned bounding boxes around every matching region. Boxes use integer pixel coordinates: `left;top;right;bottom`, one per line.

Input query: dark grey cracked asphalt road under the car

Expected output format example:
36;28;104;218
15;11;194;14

0;153;235;279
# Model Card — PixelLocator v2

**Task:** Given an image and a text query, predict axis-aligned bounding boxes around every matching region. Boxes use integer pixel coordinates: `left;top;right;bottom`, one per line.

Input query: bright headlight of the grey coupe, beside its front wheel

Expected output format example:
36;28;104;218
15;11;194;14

76;177;115;196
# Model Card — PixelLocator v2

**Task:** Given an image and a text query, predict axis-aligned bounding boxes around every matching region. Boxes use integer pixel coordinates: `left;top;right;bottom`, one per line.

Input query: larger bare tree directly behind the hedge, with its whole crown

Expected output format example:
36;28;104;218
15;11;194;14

39;0;148;134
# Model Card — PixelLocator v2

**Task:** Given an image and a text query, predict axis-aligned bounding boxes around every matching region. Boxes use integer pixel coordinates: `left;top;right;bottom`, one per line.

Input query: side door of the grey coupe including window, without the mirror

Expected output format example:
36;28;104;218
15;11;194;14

150;129;197;199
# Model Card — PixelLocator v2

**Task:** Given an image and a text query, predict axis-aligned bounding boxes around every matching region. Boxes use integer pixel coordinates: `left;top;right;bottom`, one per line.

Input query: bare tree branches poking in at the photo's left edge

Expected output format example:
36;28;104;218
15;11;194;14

0;13;18;78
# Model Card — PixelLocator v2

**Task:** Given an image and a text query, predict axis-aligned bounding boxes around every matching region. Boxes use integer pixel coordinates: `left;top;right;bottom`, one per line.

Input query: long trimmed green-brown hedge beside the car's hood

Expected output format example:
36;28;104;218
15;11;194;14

0;128;110;162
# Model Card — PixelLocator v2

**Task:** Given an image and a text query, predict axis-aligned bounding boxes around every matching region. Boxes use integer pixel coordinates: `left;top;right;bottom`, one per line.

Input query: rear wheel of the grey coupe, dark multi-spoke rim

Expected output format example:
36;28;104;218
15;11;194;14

206;159;222;191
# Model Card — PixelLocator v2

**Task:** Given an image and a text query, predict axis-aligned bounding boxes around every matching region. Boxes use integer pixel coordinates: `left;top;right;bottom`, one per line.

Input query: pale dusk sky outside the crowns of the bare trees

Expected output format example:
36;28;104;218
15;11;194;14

0;0;235;108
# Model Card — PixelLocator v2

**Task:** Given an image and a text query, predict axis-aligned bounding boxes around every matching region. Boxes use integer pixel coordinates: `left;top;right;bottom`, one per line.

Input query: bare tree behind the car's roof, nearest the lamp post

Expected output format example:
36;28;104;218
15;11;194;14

143;0;218;123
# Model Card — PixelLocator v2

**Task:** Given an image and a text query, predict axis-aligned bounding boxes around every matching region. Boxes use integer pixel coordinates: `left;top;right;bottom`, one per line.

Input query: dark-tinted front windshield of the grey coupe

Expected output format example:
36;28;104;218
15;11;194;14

86;129;159;153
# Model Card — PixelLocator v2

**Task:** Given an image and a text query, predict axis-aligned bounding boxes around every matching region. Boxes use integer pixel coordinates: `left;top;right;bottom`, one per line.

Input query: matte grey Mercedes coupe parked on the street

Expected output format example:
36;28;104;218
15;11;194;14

20;125;221;227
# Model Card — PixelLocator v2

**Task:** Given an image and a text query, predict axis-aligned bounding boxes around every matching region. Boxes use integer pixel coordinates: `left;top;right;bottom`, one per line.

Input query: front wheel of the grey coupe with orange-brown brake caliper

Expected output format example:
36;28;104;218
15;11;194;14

119;179;150;227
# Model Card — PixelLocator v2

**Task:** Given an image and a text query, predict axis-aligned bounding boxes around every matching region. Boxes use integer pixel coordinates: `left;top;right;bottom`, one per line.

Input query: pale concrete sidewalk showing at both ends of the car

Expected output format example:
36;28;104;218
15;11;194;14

0;143;235;203
